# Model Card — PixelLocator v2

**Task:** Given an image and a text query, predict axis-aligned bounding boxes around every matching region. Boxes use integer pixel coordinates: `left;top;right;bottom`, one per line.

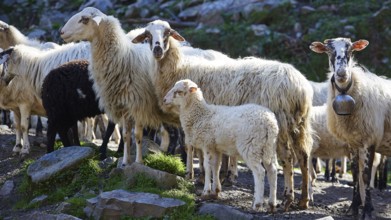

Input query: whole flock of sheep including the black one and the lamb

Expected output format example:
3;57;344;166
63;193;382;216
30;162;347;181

0;7;391;218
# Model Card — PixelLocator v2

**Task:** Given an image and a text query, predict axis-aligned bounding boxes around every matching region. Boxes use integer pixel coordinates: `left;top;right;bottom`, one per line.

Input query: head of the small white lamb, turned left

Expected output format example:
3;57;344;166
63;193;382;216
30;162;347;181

163;79;198;106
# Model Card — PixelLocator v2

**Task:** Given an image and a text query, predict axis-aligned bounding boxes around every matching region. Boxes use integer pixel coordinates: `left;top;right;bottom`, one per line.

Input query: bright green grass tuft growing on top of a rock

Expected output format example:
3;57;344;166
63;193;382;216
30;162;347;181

144;153;186;176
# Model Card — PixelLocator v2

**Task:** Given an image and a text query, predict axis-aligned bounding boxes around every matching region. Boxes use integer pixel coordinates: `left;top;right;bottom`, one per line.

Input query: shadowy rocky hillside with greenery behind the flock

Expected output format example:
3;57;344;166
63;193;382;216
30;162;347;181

0;0;391;81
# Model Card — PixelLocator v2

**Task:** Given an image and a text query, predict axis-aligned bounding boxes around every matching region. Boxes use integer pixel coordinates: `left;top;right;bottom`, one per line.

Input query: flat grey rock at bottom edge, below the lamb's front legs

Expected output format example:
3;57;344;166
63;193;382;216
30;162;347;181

198;203;253;220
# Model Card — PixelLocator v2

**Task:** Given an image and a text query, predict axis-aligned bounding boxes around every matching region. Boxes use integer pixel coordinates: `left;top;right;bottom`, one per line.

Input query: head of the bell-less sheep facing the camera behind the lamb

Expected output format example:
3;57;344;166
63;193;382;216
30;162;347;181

132;20;185;60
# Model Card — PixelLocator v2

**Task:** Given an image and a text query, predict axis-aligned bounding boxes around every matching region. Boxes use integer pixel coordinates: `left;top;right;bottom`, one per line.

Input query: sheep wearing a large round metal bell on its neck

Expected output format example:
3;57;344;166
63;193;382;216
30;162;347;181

310;38;391;219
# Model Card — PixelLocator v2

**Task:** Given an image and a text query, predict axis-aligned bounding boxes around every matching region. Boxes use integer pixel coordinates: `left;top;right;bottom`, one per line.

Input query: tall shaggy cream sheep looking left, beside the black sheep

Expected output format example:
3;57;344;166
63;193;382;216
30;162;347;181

61;7;179;165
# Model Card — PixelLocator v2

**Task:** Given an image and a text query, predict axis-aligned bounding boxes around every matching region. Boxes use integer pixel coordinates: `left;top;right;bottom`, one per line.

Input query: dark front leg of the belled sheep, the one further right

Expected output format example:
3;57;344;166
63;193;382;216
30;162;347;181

359;145;376;219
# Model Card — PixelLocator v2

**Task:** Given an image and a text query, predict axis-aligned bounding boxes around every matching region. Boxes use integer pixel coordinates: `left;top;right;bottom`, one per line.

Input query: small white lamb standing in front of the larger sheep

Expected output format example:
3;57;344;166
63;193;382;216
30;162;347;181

164;79;279;212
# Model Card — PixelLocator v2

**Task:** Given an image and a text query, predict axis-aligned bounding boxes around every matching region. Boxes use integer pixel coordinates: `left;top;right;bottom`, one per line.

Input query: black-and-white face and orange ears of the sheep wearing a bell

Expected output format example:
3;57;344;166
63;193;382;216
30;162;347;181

310;38;369;84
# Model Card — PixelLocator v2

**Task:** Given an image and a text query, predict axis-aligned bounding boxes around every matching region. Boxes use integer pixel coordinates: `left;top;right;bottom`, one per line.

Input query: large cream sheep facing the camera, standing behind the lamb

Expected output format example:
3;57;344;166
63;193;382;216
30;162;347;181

133;20;313;210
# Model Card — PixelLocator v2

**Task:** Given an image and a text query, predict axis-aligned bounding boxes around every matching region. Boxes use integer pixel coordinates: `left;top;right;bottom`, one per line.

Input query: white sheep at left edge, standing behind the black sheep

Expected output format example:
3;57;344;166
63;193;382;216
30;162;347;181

0;40;89;155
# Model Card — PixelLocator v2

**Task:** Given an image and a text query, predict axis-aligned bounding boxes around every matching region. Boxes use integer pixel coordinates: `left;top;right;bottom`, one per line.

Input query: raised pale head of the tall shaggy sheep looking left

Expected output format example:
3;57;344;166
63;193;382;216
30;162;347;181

60;7;106;42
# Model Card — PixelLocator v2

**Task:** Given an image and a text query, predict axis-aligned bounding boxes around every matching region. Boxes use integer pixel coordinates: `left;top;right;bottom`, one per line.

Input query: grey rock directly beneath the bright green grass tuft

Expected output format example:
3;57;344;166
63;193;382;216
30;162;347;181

124;163;182;189
